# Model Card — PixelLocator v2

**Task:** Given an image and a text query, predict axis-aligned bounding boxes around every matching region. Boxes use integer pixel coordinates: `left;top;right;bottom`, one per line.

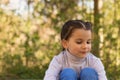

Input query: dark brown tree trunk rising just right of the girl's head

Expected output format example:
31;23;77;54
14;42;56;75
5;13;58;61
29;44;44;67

92;0;100;57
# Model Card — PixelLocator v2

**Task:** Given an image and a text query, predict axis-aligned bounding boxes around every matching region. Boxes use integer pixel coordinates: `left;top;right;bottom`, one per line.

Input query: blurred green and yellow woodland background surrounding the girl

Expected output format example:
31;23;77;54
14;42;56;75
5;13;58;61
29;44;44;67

0;0;120;80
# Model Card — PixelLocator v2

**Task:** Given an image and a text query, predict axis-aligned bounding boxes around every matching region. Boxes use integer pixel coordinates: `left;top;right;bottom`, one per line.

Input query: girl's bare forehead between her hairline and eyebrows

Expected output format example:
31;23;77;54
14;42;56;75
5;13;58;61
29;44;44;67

70;29;92;39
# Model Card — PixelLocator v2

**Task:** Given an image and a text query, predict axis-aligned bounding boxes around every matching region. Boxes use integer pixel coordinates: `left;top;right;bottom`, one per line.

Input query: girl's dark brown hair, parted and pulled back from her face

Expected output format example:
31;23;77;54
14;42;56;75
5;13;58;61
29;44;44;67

61;20;92;40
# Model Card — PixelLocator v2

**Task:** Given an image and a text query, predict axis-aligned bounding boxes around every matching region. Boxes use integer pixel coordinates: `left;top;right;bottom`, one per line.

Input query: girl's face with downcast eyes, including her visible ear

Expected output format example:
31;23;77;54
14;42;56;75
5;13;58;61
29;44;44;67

63;29;92;58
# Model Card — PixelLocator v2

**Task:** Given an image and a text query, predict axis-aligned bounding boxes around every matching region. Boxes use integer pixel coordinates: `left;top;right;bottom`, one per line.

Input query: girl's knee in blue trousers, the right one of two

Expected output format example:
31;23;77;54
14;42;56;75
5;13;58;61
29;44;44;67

80;68;98;80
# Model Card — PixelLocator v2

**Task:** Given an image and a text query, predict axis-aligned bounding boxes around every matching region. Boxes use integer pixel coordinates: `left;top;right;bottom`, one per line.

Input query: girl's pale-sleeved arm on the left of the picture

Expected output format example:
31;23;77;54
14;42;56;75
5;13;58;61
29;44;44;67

44;56;62;80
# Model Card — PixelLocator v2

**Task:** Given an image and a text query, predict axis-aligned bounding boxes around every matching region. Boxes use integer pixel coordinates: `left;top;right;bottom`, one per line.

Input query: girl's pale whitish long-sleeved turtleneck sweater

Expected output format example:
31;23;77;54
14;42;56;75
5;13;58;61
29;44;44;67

44;51;107;80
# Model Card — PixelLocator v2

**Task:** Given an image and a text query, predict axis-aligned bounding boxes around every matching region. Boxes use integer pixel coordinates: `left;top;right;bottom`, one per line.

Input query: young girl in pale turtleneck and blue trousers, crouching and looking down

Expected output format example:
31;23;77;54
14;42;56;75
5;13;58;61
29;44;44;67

44;20;107;80
